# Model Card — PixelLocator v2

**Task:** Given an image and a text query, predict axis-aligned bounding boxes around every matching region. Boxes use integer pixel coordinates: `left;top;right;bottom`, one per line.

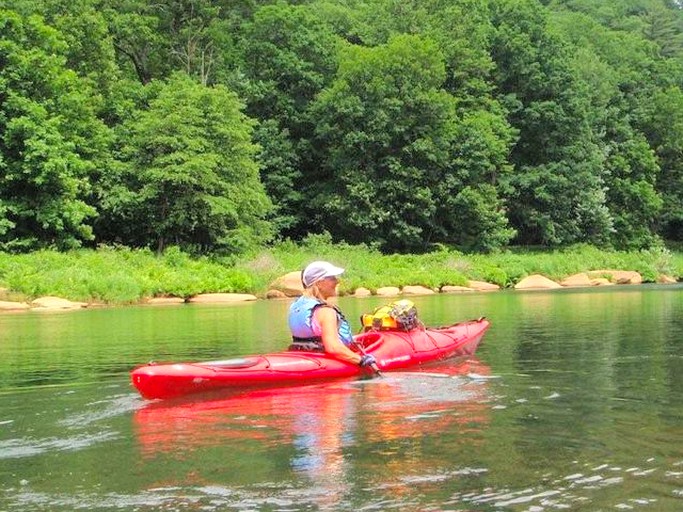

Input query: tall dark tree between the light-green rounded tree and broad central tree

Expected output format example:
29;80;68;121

240;3;338;237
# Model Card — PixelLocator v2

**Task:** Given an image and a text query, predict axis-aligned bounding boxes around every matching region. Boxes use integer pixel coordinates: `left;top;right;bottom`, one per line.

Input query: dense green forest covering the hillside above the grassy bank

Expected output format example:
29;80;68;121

0;0;683;254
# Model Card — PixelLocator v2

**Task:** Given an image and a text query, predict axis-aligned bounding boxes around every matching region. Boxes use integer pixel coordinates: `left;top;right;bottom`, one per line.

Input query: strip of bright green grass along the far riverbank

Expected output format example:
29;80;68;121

0;235;683;304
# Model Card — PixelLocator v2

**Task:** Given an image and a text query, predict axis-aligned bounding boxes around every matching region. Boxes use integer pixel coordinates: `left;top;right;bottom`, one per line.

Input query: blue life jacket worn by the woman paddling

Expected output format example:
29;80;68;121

289;295;353;350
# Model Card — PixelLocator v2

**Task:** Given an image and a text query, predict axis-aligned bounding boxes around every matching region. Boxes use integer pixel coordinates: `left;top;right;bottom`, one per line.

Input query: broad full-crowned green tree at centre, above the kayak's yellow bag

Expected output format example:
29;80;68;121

308;35;505;251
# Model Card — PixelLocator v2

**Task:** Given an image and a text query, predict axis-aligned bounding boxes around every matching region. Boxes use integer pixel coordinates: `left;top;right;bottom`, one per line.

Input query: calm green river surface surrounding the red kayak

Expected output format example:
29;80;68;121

0;285;683;512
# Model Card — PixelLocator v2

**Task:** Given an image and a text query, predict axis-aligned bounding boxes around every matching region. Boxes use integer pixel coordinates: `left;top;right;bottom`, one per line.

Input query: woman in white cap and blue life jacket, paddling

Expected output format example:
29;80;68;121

289;261;375;366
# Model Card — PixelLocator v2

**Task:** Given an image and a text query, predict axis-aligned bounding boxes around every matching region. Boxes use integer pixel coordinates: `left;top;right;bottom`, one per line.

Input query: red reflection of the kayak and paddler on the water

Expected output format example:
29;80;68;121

133;359;490;510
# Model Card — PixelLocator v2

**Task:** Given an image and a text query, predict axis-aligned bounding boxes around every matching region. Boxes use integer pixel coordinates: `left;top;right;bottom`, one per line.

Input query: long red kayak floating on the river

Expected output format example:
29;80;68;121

131;318;490;399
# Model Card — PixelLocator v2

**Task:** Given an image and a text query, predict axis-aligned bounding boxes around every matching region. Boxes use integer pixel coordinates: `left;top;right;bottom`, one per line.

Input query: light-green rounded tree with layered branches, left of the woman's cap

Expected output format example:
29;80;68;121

103;74;271;253
